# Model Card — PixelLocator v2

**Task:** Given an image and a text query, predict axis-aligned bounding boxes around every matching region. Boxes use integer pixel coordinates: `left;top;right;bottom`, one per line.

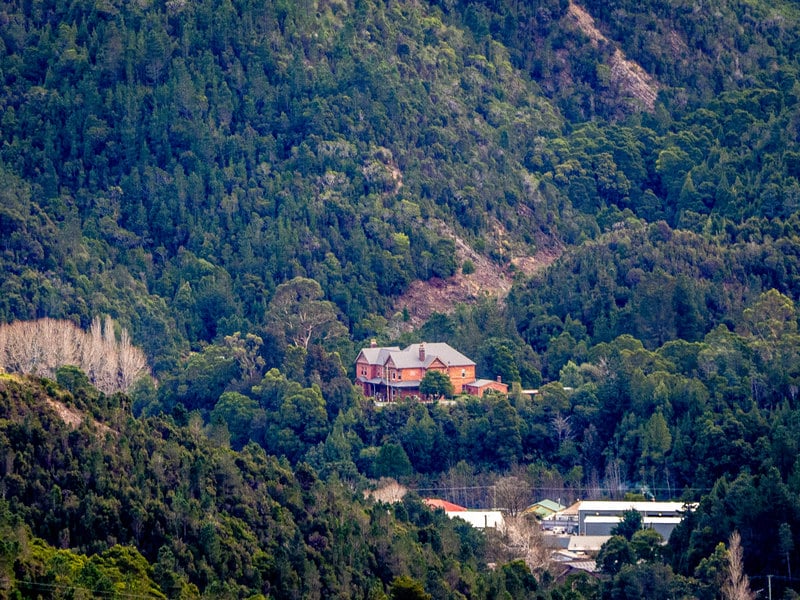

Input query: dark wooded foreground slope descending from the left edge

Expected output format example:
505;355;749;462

0;376;516;598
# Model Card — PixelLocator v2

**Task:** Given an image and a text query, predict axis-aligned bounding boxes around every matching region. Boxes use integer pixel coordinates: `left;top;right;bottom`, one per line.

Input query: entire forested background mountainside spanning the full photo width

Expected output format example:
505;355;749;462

0;1;800;371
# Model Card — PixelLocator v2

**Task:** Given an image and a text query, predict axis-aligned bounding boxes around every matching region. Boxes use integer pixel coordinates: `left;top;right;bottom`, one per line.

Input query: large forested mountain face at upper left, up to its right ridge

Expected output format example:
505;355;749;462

0;2;572;374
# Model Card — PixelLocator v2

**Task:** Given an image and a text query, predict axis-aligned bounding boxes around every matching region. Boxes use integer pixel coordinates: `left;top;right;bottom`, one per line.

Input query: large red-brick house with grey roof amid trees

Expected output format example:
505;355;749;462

356;342;506;401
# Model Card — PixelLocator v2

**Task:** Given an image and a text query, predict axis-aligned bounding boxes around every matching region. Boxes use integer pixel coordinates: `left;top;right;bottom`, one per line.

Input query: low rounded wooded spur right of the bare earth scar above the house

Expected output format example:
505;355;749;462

513;220;800;354
